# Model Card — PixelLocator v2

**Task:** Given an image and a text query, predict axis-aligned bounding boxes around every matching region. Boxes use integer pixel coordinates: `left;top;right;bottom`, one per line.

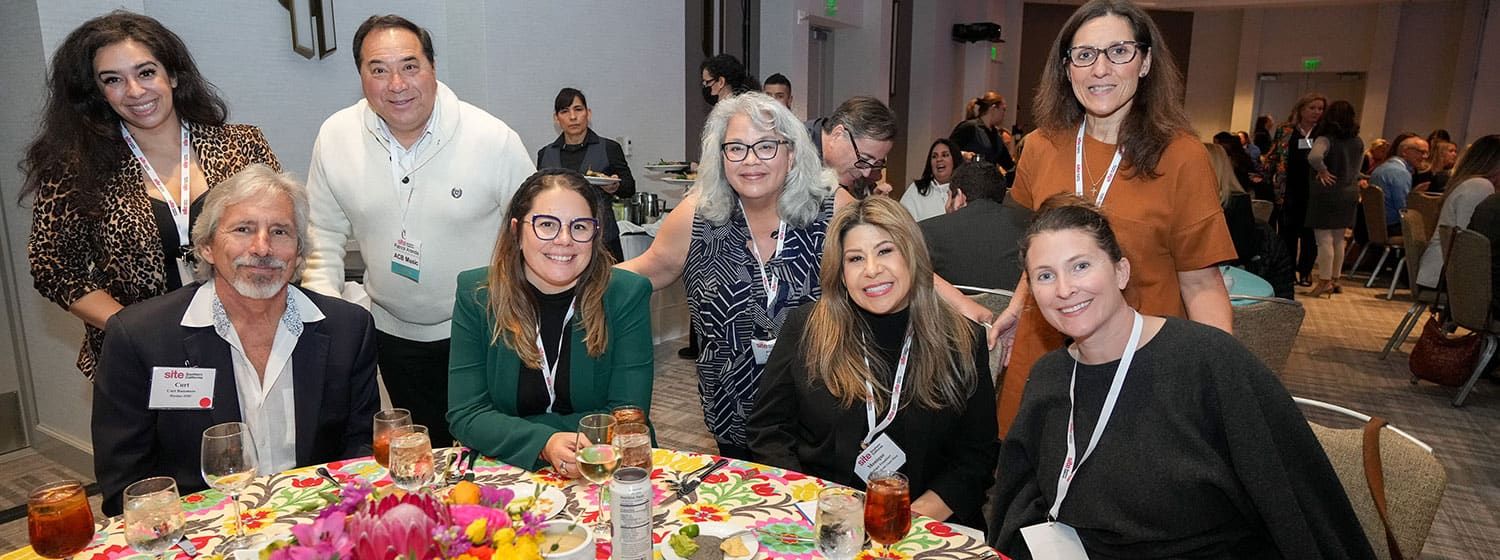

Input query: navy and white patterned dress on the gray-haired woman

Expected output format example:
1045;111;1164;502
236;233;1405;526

683;195;834;447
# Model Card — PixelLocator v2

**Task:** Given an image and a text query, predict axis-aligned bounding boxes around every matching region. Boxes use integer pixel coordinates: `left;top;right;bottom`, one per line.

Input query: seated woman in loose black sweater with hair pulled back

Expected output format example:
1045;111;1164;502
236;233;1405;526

990;195;1374;558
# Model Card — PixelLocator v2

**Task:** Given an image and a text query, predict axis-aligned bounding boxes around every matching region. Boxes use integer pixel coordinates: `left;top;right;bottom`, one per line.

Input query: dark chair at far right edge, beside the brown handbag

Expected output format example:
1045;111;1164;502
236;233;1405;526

1443;228;1500;407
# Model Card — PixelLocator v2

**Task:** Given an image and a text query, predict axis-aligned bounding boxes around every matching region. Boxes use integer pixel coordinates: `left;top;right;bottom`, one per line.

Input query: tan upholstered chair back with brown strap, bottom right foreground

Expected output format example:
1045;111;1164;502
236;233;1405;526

1293;398;1448;558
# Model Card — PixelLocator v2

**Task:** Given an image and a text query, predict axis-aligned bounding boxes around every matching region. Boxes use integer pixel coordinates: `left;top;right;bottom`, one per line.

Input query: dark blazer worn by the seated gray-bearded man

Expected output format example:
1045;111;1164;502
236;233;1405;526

92;284;380;515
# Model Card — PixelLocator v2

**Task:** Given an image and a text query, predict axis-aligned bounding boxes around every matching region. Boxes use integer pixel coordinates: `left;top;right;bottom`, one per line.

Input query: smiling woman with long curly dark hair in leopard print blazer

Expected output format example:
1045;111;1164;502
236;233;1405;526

21;12;281;378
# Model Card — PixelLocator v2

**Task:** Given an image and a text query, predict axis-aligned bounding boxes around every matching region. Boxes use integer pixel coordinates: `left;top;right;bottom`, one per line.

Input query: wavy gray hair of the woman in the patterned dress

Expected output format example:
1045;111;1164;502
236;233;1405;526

695;92;837;228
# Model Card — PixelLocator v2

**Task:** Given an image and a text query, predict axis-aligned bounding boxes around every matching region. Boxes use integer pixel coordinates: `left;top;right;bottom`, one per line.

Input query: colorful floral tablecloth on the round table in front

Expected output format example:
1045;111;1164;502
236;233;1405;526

11;449;996;560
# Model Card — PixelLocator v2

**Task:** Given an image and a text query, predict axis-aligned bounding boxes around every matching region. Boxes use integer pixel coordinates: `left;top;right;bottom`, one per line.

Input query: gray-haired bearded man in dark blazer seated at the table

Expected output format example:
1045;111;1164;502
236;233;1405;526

93;165;380;515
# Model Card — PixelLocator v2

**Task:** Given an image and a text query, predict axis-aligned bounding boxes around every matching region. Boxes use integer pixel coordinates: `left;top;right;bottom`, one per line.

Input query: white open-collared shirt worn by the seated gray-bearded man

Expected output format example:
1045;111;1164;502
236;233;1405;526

182;281;324;473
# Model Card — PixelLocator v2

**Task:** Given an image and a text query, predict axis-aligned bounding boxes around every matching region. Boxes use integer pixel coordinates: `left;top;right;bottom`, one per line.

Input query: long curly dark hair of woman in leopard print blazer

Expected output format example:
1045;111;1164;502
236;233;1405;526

18;11;230;213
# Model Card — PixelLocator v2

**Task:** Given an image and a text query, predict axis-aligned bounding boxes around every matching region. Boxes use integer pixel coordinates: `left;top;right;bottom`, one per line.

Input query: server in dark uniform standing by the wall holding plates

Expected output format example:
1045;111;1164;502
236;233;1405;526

537;87;636;263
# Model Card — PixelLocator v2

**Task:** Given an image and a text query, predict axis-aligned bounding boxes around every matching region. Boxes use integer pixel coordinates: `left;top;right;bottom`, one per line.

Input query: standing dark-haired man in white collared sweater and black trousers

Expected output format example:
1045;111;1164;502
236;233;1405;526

303;15;536;446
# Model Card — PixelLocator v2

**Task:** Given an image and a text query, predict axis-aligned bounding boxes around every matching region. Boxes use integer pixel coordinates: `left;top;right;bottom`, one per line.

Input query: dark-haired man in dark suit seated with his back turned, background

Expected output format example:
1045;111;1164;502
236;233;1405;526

918;162;1031;290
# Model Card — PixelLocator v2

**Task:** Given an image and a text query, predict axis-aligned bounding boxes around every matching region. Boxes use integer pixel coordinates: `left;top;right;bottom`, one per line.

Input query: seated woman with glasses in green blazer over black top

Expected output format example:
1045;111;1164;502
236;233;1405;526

449;170;653;477
